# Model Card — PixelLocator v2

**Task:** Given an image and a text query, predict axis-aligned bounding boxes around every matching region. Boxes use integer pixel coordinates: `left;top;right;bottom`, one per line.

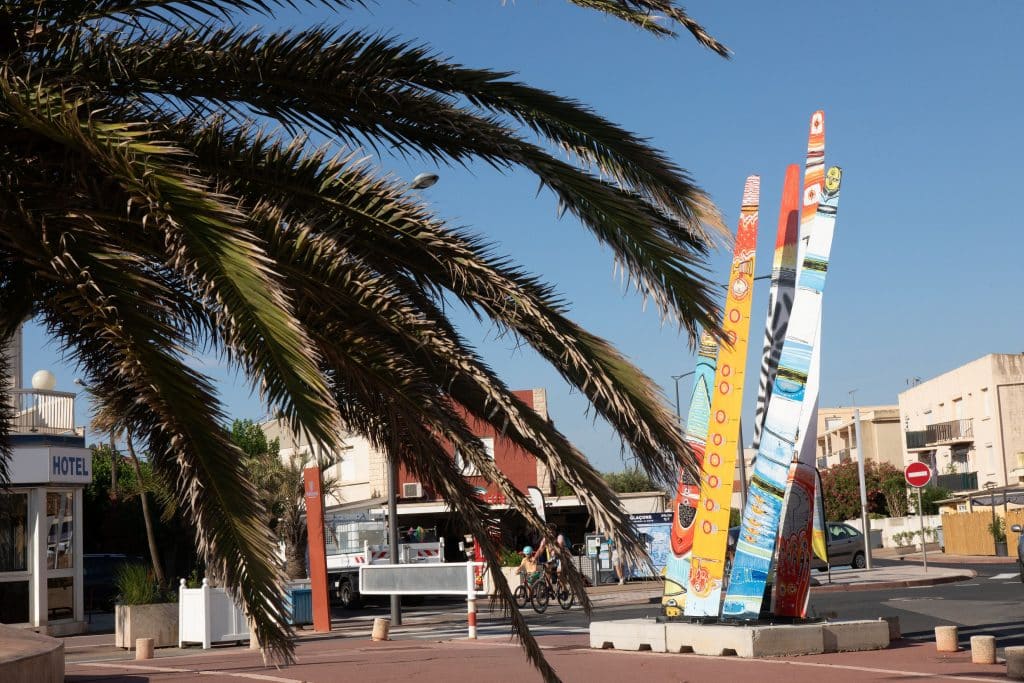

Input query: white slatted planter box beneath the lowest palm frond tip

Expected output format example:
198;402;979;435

178;579;249;649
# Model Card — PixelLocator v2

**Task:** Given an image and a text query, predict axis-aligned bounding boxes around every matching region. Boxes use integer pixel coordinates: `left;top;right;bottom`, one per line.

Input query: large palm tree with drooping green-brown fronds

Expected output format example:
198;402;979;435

0;0;726;679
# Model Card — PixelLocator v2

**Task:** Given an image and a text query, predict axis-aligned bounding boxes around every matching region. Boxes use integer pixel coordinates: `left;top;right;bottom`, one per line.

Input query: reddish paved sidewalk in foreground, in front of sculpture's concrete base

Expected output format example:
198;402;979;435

66;635;1006;683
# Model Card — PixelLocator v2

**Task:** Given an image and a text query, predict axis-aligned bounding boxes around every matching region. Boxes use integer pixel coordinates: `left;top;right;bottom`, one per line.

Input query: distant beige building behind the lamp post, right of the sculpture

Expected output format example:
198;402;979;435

815;405;903;470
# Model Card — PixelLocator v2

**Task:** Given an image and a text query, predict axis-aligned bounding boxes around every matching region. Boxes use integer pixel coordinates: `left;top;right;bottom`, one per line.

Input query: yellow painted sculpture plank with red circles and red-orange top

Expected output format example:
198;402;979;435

684;175;761;616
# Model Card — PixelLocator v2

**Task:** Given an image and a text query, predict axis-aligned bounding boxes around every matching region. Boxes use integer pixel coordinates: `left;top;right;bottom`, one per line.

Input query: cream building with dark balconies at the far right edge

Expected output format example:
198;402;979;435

899;353;1024;493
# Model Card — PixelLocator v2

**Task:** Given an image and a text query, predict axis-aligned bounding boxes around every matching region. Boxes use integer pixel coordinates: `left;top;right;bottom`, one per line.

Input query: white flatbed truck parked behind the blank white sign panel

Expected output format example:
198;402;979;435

324;515;444;608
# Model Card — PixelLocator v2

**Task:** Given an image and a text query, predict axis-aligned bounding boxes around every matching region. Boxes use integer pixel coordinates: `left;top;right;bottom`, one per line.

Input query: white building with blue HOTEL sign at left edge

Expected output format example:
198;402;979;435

0;332;92;635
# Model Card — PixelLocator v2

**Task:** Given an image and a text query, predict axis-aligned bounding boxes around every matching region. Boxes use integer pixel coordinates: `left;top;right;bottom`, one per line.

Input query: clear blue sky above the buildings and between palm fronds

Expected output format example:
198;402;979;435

18;0;1024;470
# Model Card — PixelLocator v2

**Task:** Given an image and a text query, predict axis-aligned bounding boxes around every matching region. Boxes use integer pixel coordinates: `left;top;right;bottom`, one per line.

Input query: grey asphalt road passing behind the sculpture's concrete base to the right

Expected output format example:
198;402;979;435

335;560;1024;648
